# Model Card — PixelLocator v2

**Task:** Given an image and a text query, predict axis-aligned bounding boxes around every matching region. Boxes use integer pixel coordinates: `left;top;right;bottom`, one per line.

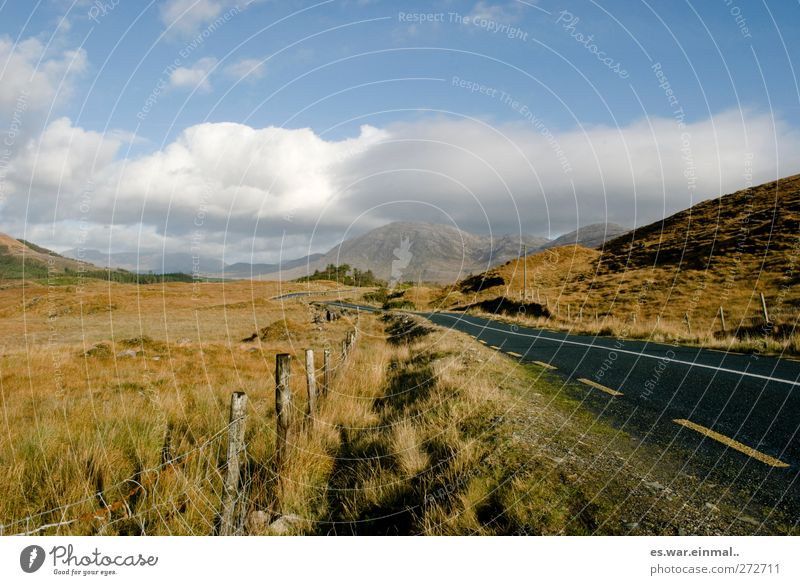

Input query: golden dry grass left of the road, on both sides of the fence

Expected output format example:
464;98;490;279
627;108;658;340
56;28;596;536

0;283;792;534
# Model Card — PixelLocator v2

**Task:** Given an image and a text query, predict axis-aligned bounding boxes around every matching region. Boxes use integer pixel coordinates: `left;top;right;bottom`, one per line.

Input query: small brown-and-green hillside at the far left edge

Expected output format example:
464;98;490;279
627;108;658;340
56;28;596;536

0;233;97;280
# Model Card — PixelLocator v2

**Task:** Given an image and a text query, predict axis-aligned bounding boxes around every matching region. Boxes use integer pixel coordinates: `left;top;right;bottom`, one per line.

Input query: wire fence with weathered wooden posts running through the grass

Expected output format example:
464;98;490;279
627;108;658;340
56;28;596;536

0;328;358;536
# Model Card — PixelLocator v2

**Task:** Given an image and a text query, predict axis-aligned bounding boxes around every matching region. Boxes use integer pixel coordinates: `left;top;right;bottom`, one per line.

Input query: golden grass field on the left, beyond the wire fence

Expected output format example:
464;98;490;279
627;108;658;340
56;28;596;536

0;282;351;534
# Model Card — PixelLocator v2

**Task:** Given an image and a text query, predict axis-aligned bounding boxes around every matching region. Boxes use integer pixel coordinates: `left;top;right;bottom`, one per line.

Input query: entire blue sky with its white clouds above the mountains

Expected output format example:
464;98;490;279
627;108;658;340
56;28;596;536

0;0;800;263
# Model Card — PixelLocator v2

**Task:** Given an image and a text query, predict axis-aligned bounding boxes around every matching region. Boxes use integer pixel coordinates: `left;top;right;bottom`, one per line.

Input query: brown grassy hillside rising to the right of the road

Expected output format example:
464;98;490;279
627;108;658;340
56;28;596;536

448;175;800;332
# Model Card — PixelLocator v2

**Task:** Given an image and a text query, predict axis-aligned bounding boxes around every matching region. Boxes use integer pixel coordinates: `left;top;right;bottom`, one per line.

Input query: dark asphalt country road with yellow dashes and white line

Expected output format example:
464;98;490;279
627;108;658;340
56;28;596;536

326;303;800;510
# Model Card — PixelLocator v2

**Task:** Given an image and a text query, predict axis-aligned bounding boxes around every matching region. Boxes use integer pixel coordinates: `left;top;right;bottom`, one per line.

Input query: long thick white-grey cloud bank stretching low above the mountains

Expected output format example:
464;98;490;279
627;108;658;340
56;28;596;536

0;111;800;261
